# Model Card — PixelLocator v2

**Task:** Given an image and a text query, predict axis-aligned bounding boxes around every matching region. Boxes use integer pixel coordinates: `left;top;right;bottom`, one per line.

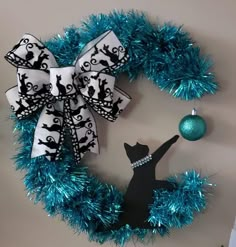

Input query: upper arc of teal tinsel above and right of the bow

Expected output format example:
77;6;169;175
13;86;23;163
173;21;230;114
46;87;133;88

46;11;218;100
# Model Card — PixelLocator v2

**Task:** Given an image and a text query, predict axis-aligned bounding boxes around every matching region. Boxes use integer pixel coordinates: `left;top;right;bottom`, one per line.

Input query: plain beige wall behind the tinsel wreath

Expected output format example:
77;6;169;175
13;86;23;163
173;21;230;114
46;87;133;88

0;0;236;247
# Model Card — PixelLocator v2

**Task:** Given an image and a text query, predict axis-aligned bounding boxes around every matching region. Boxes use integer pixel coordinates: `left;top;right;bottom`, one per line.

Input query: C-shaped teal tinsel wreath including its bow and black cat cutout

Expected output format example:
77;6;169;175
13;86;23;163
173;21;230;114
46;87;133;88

6;11;218;245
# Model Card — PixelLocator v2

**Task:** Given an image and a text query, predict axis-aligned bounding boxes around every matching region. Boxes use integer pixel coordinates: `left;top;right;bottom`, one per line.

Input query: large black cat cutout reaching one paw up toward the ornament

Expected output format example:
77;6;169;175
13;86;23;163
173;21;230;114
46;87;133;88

109;135;179;230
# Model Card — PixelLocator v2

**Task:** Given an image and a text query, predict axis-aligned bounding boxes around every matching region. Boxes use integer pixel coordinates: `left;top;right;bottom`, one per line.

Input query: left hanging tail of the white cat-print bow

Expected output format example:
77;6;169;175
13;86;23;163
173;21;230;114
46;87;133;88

31;101;65;161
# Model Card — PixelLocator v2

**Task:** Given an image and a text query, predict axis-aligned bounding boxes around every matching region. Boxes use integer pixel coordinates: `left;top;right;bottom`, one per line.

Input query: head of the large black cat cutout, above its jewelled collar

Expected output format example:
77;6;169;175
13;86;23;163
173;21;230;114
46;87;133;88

124;142;149;163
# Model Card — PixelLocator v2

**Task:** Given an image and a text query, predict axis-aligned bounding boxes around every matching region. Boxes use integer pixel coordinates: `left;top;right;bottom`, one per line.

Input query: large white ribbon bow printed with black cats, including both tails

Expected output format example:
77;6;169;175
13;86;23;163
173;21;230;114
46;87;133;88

5;31;131;162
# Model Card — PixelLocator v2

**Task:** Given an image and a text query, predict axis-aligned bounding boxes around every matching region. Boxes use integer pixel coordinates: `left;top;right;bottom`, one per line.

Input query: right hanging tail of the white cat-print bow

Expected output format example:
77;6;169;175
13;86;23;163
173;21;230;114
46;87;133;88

65;95;99;162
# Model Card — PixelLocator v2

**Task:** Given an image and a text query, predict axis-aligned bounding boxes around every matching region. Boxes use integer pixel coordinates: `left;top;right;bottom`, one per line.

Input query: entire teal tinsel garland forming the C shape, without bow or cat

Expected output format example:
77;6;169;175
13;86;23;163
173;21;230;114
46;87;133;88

11;12;217;246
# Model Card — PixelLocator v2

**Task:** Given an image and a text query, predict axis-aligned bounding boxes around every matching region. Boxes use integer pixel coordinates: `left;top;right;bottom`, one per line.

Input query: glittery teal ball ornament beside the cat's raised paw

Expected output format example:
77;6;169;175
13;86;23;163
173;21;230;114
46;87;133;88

179;109;207;141
